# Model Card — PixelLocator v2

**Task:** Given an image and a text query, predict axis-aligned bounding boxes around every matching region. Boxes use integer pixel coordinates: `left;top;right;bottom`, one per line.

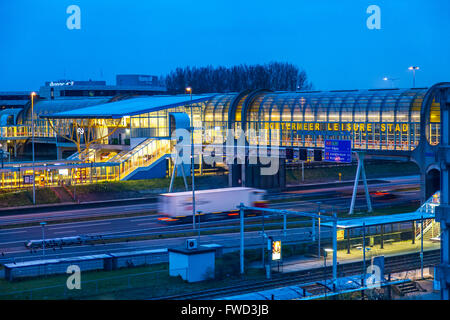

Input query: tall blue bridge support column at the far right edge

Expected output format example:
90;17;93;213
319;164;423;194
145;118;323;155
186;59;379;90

435;89;450;300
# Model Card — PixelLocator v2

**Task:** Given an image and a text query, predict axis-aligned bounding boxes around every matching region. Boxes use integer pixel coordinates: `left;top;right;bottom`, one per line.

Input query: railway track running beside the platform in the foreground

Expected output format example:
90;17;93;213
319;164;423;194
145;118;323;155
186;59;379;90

156;250;440;300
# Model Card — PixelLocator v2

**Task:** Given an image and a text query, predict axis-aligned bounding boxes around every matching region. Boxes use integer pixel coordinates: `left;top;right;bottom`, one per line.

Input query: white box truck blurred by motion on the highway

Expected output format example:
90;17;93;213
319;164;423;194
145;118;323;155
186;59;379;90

158;187;267;220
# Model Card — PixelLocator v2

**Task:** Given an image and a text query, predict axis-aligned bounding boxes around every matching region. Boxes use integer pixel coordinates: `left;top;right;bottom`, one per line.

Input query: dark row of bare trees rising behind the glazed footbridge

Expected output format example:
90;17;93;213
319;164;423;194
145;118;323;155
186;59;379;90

165;62;312;94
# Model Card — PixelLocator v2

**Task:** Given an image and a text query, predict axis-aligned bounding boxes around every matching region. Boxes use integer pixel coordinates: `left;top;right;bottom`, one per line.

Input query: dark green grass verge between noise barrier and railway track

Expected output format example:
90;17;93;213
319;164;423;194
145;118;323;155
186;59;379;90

0;245;307;300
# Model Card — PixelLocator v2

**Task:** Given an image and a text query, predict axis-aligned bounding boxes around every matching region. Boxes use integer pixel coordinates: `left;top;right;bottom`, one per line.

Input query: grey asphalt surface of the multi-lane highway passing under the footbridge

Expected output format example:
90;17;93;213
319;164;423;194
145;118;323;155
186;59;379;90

0;177;419;263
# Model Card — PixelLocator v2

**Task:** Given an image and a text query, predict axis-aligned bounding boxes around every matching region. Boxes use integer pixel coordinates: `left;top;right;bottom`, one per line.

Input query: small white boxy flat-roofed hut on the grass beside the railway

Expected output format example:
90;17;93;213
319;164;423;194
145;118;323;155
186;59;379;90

168;248;216;282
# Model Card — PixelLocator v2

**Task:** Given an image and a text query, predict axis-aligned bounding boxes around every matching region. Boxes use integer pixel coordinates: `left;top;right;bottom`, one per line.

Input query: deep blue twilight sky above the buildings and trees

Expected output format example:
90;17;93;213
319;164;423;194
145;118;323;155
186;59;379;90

0;0;450;91
